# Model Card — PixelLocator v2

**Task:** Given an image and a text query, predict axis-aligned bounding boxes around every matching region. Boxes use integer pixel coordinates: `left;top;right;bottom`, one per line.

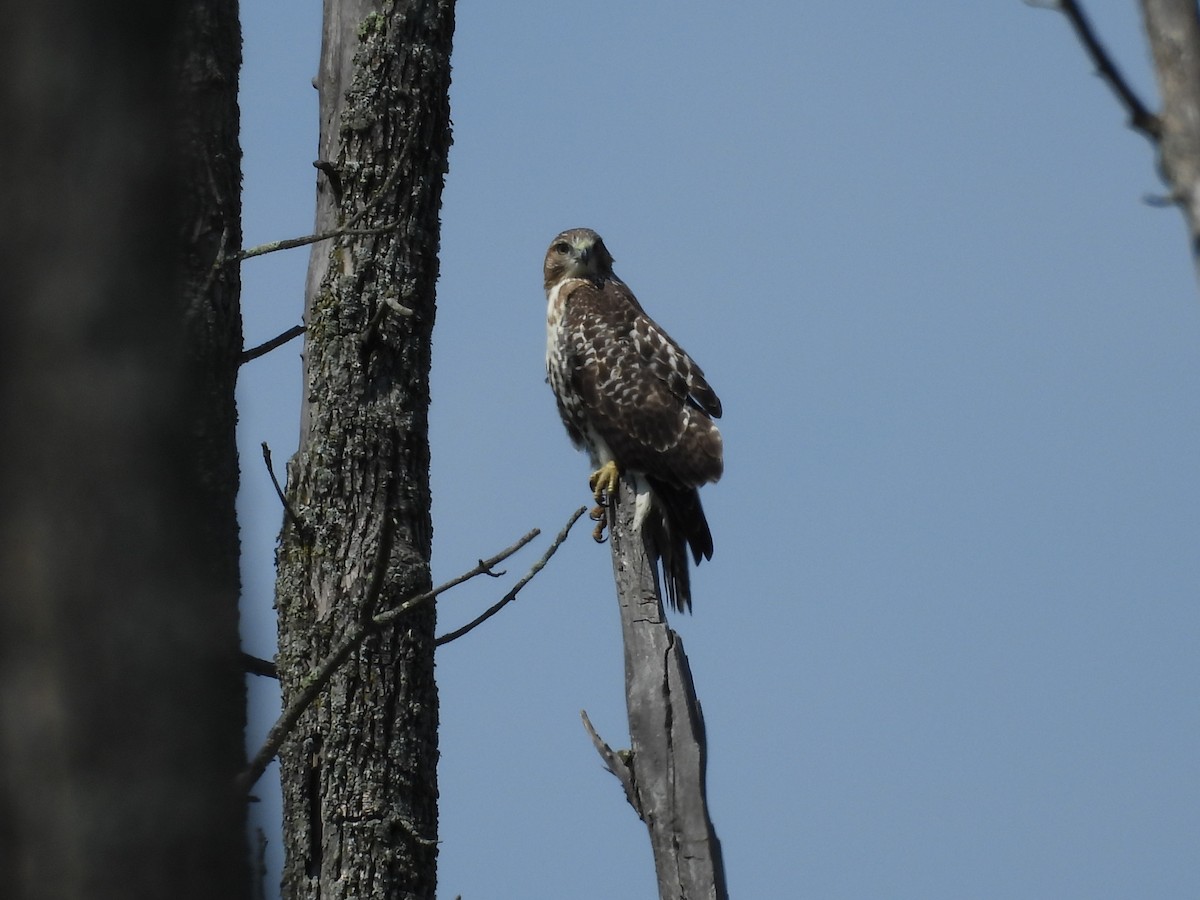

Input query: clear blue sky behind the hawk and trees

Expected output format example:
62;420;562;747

240;0;1200;900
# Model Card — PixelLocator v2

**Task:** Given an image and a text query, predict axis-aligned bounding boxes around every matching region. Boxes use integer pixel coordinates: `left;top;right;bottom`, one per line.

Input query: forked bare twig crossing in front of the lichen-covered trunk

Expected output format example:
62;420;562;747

238;525;541;791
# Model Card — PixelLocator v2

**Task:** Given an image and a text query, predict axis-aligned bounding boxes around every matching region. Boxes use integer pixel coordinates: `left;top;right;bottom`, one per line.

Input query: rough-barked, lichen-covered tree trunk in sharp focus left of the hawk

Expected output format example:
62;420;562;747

276;0;454;900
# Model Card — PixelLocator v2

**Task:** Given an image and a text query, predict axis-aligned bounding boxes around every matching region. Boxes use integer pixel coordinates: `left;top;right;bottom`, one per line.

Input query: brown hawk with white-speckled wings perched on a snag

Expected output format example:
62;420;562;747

545;228;724;611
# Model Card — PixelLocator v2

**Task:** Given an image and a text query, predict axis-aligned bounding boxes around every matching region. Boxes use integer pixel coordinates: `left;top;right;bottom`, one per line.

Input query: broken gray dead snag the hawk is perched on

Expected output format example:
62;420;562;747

589;478;728;900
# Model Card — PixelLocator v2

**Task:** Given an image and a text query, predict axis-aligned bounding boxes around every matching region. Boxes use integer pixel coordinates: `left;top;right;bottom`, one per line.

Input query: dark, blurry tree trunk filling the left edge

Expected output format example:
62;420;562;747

0;0;250;900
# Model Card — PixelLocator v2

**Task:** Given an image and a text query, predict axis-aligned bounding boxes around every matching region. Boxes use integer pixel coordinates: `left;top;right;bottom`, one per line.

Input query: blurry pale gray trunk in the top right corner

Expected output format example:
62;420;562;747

1141;0;1200;280
